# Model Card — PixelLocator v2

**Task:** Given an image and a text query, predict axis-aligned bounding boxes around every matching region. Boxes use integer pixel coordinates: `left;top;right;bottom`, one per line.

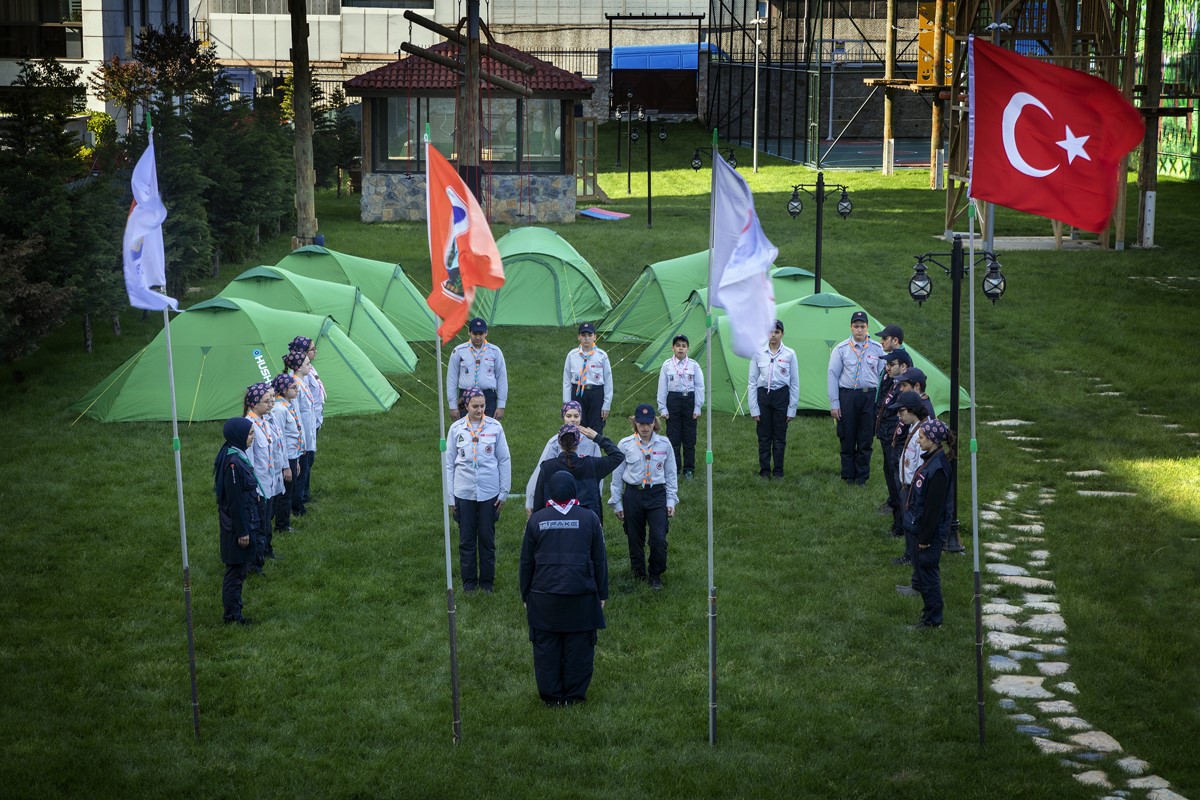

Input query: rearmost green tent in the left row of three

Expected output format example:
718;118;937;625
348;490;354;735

275;245;437;342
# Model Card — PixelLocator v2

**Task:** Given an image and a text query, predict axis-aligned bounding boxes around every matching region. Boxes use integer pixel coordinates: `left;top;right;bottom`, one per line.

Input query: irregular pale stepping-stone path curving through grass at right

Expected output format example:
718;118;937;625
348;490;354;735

979;419;1187;800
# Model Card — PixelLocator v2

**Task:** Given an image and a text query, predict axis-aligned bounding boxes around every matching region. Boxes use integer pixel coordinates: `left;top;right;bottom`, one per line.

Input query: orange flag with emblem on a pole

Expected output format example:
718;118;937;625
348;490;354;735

425;143;504;344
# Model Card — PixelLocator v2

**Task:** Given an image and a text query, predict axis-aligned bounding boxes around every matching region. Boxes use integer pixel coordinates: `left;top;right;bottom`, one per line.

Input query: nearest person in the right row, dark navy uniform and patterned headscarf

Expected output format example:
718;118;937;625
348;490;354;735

904;419;954;630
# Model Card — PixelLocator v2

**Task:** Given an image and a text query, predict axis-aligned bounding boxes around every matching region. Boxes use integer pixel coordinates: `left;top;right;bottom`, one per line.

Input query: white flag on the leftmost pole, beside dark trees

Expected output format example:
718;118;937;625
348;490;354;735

121;134;179;311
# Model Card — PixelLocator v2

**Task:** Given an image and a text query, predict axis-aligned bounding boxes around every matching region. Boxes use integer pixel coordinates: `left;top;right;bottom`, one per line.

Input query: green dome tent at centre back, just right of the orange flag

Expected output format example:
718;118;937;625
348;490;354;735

472;228;612;327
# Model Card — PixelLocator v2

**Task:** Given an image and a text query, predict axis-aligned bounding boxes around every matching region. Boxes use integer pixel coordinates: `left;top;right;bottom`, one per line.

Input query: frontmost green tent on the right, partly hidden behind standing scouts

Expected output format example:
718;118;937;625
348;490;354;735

692;293;971;414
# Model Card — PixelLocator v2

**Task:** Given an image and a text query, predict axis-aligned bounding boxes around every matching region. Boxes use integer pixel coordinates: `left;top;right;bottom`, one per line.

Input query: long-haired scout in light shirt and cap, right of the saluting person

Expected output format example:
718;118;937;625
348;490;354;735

608;403;679;591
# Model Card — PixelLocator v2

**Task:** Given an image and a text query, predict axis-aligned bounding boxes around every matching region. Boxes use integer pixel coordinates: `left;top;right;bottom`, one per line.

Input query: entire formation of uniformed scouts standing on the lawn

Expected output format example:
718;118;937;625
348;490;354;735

215;312;953;705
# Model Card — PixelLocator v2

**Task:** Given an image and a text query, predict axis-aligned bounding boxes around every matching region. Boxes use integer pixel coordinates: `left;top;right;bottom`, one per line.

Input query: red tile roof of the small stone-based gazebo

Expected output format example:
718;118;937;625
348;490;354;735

344;42;594;97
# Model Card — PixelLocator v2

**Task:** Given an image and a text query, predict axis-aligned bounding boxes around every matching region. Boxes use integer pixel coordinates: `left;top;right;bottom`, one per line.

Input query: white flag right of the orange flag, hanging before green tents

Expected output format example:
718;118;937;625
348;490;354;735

708;154;779;357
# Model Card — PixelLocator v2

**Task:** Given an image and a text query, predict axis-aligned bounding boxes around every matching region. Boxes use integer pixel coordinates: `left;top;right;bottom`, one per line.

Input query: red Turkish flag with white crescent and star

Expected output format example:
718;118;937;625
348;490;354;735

968;36;1146;233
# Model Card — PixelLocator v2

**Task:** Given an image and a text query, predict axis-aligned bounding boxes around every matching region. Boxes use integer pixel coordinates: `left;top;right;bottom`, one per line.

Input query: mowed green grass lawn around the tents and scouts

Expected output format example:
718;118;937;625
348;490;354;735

0;120;1200;799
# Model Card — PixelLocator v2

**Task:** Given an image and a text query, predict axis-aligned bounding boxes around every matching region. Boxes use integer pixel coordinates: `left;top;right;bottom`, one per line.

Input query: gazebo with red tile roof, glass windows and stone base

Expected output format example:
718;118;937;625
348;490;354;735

344;42;593;223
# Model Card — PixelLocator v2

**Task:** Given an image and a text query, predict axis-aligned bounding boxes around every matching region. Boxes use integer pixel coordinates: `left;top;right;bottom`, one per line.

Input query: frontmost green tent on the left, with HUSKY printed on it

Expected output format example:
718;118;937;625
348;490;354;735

73;297;400;422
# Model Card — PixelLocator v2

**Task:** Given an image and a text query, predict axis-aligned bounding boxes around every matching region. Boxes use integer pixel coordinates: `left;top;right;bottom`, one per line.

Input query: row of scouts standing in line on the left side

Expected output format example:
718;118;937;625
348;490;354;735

212;336;325;625
